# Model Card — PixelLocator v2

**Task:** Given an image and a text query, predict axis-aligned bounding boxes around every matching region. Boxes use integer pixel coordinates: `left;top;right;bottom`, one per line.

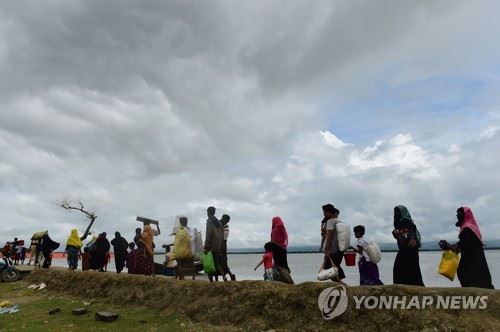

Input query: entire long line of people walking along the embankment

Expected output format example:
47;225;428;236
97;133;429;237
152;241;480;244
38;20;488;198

3;204;494;289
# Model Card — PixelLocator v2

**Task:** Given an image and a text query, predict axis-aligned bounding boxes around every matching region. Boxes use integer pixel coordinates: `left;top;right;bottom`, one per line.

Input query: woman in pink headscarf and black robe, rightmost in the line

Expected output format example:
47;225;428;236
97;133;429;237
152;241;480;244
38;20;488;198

439;206;494;289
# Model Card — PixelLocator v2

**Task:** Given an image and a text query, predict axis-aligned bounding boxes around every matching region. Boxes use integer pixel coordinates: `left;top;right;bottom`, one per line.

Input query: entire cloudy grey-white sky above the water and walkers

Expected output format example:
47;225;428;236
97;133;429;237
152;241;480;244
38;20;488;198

0;0;500;247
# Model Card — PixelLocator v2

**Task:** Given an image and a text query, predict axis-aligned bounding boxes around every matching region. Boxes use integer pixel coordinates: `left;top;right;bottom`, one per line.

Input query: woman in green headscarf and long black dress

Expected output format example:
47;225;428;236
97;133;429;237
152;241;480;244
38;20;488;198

392;205;424;286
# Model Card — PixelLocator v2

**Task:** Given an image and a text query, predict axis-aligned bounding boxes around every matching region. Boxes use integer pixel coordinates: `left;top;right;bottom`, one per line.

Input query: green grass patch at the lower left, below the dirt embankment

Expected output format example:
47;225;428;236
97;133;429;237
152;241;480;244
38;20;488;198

0;282;234;332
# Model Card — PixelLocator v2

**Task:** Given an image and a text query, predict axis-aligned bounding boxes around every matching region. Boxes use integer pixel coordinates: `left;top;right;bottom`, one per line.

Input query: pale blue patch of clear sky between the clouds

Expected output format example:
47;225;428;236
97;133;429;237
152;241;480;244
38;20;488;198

323;73;491;145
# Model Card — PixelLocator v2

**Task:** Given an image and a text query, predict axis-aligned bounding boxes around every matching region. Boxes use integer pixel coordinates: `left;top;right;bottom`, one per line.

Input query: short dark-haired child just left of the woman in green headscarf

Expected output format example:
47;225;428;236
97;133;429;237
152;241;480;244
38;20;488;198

351;225;383;286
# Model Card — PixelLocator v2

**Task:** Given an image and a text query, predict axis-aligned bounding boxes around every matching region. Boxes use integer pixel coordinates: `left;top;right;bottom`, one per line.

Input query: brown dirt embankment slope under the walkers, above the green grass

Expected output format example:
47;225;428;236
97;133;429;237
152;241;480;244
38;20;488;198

21;270;500;331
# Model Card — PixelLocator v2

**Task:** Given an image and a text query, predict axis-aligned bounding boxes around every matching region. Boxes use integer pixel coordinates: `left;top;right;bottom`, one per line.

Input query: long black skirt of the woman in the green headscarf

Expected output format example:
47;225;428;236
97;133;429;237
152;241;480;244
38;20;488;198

393;248;424;286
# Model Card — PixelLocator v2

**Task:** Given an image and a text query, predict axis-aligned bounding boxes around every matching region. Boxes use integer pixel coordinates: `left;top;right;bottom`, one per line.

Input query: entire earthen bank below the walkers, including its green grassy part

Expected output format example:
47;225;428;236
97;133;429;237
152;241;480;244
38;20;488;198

0;270;500;331
